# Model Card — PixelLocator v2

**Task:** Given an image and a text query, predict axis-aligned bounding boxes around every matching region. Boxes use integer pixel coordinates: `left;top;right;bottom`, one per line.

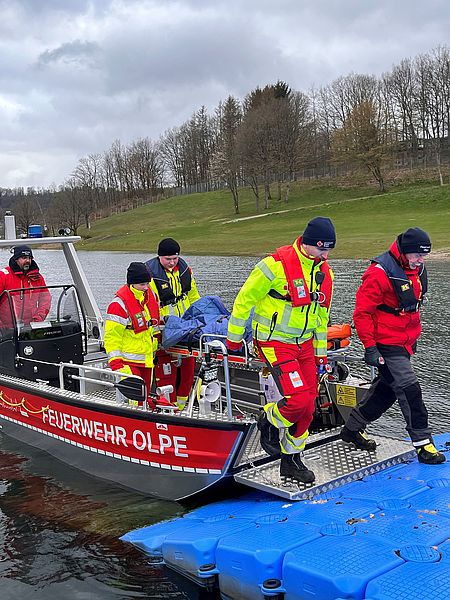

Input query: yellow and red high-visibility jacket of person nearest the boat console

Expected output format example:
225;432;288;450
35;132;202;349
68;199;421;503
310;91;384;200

104;285;159;370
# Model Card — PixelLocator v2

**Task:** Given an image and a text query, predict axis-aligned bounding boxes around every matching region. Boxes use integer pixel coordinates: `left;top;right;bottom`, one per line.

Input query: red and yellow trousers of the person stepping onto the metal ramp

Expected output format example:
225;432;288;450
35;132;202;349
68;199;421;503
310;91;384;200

258;339;318;454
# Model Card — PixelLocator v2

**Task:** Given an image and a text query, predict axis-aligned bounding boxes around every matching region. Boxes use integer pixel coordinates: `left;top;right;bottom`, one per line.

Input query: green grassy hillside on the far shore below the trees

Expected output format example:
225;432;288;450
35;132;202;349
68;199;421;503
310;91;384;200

77;182;450;258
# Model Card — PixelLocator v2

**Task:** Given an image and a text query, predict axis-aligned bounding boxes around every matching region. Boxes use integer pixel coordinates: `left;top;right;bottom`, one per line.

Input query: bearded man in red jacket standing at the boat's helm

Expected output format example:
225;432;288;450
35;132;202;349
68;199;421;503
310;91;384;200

0;246;52;327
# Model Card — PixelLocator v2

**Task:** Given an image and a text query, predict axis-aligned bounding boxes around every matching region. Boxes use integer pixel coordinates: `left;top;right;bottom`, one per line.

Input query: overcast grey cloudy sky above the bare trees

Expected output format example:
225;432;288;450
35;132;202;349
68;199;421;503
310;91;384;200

0;0;450;187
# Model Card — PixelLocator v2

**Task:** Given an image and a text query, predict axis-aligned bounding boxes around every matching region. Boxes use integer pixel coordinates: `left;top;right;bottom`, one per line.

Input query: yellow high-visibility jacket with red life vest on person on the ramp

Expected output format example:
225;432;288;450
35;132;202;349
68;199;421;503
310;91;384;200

227;238;333;357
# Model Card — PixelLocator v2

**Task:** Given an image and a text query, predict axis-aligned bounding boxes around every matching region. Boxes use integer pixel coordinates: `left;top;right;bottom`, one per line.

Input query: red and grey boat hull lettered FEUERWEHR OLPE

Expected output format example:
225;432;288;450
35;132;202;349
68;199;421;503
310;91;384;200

0;381;249;500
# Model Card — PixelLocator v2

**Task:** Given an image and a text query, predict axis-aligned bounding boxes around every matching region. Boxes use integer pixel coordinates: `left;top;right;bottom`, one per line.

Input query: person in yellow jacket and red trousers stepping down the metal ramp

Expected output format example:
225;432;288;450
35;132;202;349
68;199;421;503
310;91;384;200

227;217;336;483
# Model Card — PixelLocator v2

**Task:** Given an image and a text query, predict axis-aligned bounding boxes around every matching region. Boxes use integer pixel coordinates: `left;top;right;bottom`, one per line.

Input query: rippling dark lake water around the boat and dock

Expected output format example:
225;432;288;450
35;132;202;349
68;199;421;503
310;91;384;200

0;250;450;600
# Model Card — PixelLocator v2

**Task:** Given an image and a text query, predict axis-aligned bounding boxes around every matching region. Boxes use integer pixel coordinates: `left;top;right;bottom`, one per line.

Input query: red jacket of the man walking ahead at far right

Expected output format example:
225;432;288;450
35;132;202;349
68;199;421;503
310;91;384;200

353;242;422;354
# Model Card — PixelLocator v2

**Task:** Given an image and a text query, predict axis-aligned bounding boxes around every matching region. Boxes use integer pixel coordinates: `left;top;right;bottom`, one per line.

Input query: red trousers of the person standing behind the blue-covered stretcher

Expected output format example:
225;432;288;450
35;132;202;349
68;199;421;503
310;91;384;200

155;350;195;408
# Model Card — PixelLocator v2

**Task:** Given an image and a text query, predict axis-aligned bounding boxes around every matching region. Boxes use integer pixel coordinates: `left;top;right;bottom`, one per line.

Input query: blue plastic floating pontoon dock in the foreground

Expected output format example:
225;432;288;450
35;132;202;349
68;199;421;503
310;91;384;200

122;434;450;600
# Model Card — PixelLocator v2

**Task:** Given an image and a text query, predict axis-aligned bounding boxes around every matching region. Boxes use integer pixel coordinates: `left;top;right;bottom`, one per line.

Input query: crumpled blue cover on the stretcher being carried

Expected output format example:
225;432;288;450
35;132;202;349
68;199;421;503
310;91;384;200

162;296;252;348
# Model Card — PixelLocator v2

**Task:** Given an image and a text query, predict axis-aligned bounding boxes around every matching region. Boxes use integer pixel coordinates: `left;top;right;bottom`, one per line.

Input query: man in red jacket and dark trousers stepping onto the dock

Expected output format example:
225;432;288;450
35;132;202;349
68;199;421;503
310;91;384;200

341;227;445;465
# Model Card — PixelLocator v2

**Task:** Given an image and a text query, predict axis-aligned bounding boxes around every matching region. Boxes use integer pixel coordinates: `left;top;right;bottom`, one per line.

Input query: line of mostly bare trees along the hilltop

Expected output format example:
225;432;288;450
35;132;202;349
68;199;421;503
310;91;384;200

0;46;450;233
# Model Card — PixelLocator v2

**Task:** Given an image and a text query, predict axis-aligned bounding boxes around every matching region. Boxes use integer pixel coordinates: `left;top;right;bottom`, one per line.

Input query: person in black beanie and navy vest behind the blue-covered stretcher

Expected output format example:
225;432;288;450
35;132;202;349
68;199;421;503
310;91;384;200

145;238;200;410
